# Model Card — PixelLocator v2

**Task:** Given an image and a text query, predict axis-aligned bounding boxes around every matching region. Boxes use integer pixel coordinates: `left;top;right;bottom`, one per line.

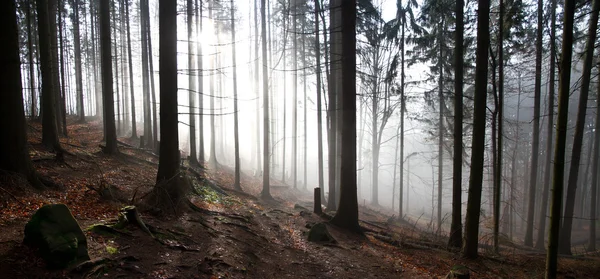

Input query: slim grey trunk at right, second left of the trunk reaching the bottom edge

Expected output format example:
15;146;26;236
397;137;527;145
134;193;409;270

524;0;544;247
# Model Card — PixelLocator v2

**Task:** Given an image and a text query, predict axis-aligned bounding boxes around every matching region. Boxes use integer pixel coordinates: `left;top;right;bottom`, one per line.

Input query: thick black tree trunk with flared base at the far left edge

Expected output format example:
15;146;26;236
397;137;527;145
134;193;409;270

0;0;47;188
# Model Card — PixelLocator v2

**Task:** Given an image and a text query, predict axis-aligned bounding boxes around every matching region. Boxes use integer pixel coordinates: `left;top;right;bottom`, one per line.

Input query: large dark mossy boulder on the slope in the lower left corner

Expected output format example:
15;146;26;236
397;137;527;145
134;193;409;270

23;204;90;268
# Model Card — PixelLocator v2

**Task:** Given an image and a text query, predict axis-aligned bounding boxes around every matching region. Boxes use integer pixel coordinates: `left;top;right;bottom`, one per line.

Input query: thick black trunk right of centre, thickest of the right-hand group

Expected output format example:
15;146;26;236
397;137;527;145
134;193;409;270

462;0;490;258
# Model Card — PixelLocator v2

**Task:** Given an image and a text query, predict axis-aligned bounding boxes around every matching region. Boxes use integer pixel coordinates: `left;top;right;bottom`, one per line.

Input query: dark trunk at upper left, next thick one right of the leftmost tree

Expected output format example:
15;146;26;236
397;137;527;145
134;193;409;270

36;0;62;151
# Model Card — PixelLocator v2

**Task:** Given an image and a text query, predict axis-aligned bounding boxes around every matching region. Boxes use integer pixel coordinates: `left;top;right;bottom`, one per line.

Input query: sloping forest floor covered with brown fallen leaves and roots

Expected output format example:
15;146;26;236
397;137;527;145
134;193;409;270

0;118;600;278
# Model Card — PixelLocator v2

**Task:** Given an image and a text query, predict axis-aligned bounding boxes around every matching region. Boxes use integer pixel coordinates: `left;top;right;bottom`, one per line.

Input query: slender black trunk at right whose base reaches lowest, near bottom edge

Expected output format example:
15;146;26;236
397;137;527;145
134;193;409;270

546;0;575;279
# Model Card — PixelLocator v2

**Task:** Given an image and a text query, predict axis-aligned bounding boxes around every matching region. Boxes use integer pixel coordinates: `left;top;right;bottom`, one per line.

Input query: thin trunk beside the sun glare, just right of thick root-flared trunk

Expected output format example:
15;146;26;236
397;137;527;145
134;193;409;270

187;0;199;165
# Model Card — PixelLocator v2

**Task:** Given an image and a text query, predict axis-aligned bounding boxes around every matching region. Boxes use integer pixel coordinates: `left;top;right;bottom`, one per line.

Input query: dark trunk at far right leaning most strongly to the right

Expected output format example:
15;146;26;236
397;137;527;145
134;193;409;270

558;0;600;255
